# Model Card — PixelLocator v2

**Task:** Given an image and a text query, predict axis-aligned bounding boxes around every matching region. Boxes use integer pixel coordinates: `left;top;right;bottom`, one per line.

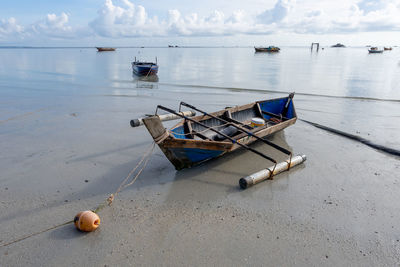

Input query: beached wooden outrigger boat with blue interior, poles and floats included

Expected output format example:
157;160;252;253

130;93;306;188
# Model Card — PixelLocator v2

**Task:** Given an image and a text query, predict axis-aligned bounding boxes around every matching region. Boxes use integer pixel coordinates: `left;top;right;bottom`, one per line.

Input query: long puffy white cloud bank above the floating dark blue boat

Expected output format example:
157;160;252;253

89;0;278;38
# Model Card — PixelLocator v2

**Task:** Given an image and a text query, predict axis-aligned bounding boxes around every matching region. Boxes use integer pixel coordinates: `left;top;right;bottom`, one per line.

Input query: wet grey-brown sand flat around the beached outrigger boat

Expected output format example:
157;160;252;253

0;91;400;266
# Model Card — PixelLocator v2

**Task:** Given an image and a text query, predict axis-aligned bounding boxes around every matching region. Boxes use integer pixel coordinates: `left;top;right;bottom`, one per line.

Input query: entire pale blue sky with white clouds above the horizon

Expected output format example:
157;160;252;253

0;0;400;46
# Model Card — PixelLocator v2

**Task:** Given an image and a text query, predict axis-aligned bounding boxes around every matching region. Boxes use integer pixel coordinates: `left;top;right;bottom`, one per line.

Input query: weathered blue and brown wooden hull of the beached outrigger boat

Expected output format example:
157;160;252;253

143;98;297;170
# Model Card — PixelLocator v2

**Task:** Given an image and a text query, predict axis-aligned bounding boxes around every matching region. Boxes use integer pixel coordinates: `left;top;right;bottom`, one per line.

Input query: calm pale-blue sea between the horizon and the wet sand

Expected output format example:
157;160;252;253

0;47;400;149
